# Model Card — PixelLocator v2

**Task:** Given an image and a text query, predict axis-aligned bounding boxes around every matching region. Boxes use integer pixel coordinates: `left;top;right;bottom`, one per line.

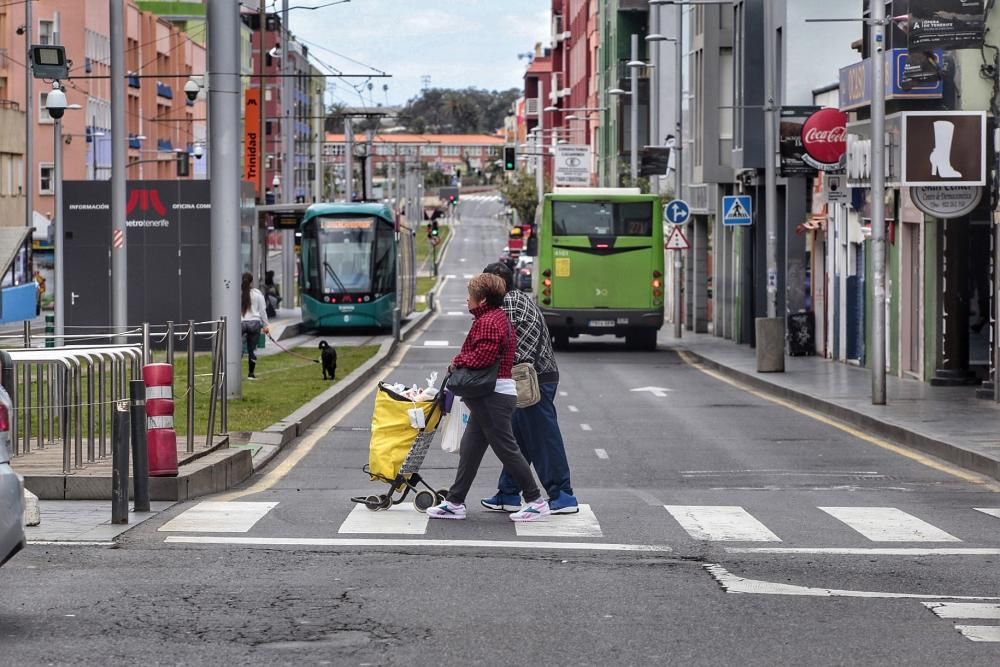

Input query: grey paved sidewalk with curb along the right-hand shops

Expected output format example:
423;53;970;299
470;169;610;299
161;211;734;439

659;326;1000;479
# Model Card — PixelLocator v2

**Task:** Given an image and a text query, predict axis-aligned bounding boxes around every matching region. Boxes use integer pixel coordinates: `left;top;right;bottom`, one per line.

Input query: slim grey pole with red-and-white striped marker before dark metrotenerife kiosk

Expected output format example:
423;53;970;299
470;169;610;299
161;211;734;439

109;0;126;343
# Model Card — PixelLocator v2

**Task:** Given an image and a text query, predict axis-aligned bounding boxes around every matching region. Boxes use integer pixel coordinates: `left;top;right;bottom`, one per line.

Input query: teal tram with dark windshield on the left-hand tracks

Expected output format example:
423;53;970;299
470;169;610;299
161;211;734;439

299;202;416;331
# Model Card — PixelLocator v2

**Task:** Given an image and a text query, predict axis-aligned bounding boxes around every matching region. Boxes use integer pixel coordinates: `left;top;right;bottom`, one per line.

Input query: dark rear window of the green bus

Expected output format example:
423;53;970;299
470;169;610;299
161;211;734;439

552;201;653;236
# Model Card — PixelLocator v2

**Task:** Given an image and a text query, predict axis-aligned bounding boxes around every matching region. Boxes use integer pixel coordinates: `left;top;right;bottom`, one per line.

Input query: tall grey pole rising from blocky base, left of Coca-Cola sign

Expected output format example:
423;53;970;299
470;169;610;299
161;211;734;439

754;2;785;373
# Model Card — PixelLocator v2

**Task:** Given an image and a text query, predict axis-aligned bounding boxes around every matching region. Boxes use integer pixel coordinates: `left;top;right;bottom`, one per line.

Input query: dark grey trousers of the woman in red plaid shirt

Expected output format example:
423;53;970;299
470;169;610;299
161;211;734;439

448;392;542;504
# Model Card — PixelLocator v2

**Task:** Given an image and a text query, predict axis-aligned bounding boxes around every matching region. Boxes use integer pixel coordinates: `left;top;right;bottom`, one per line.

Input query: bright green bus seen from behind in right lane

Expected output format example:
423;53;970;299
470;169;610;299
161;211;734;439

535;188;664;350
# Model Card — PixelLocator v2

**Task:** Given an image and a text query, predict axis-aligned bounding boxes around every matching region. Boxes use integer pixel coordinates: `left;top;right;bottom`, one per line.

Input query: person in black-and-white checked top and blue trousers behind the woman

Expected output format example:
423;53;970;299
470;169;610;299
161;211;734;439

480;262;580;514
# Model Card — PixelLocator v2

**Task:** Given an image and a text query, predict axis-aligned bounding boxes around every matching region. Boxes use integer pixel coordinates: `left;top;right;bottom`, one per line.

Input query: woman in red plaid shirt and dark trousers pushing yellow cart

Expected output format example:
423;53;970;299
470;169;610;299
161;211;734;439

427;273;549;521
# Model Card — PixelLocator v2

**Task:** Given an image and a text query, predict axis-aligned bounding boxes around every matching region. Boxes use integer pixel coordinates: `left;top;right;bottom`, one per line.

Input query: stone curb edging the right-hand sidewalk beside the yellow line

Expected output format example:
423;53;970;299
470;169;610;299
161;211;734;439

684;347;1000;480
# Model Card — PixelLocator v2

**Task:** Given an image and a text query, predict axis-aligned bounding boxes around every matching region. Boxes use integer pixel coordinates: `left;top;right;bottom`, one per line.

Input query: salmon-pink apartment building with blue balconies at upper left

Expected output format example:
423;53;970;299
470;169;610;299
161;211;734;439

0;0;207;226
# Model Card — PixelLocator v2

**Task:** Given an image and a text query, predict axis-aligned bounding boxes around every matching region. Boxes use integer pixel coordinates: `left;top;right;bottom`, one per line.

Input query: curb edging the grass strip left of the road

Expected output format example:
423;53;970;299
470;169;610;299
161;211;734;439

247;310;434;472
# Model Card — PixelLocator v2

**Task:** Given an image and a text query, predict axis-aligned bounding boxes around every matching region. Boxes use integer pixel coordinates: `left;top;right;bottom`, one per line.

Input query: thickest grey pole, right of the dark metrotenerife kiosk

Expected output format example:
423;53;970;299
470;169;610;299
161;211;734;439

205;0;243;399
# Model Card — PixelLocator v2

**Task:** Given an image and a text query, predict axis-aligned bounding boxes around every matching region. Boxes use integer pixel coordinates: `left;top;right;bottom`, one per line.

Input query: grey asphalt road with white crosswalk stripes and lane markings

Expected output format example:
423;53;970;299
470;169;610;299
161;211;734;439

0;190;1000;665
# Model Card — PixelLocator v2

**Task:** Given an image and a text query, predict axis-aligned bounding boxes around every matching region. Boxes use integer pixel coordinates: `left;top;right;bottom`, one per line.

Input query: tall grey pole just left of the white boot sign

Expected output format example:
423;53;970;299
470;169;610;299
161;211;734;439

869;0;885;405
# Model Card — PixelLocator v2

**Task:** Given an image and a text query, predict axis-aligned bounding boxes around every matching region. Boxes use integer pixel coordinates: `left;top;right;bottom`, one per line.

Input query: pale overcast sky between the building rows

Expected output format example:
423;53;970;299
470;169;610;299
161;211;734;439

286;0;551;106
